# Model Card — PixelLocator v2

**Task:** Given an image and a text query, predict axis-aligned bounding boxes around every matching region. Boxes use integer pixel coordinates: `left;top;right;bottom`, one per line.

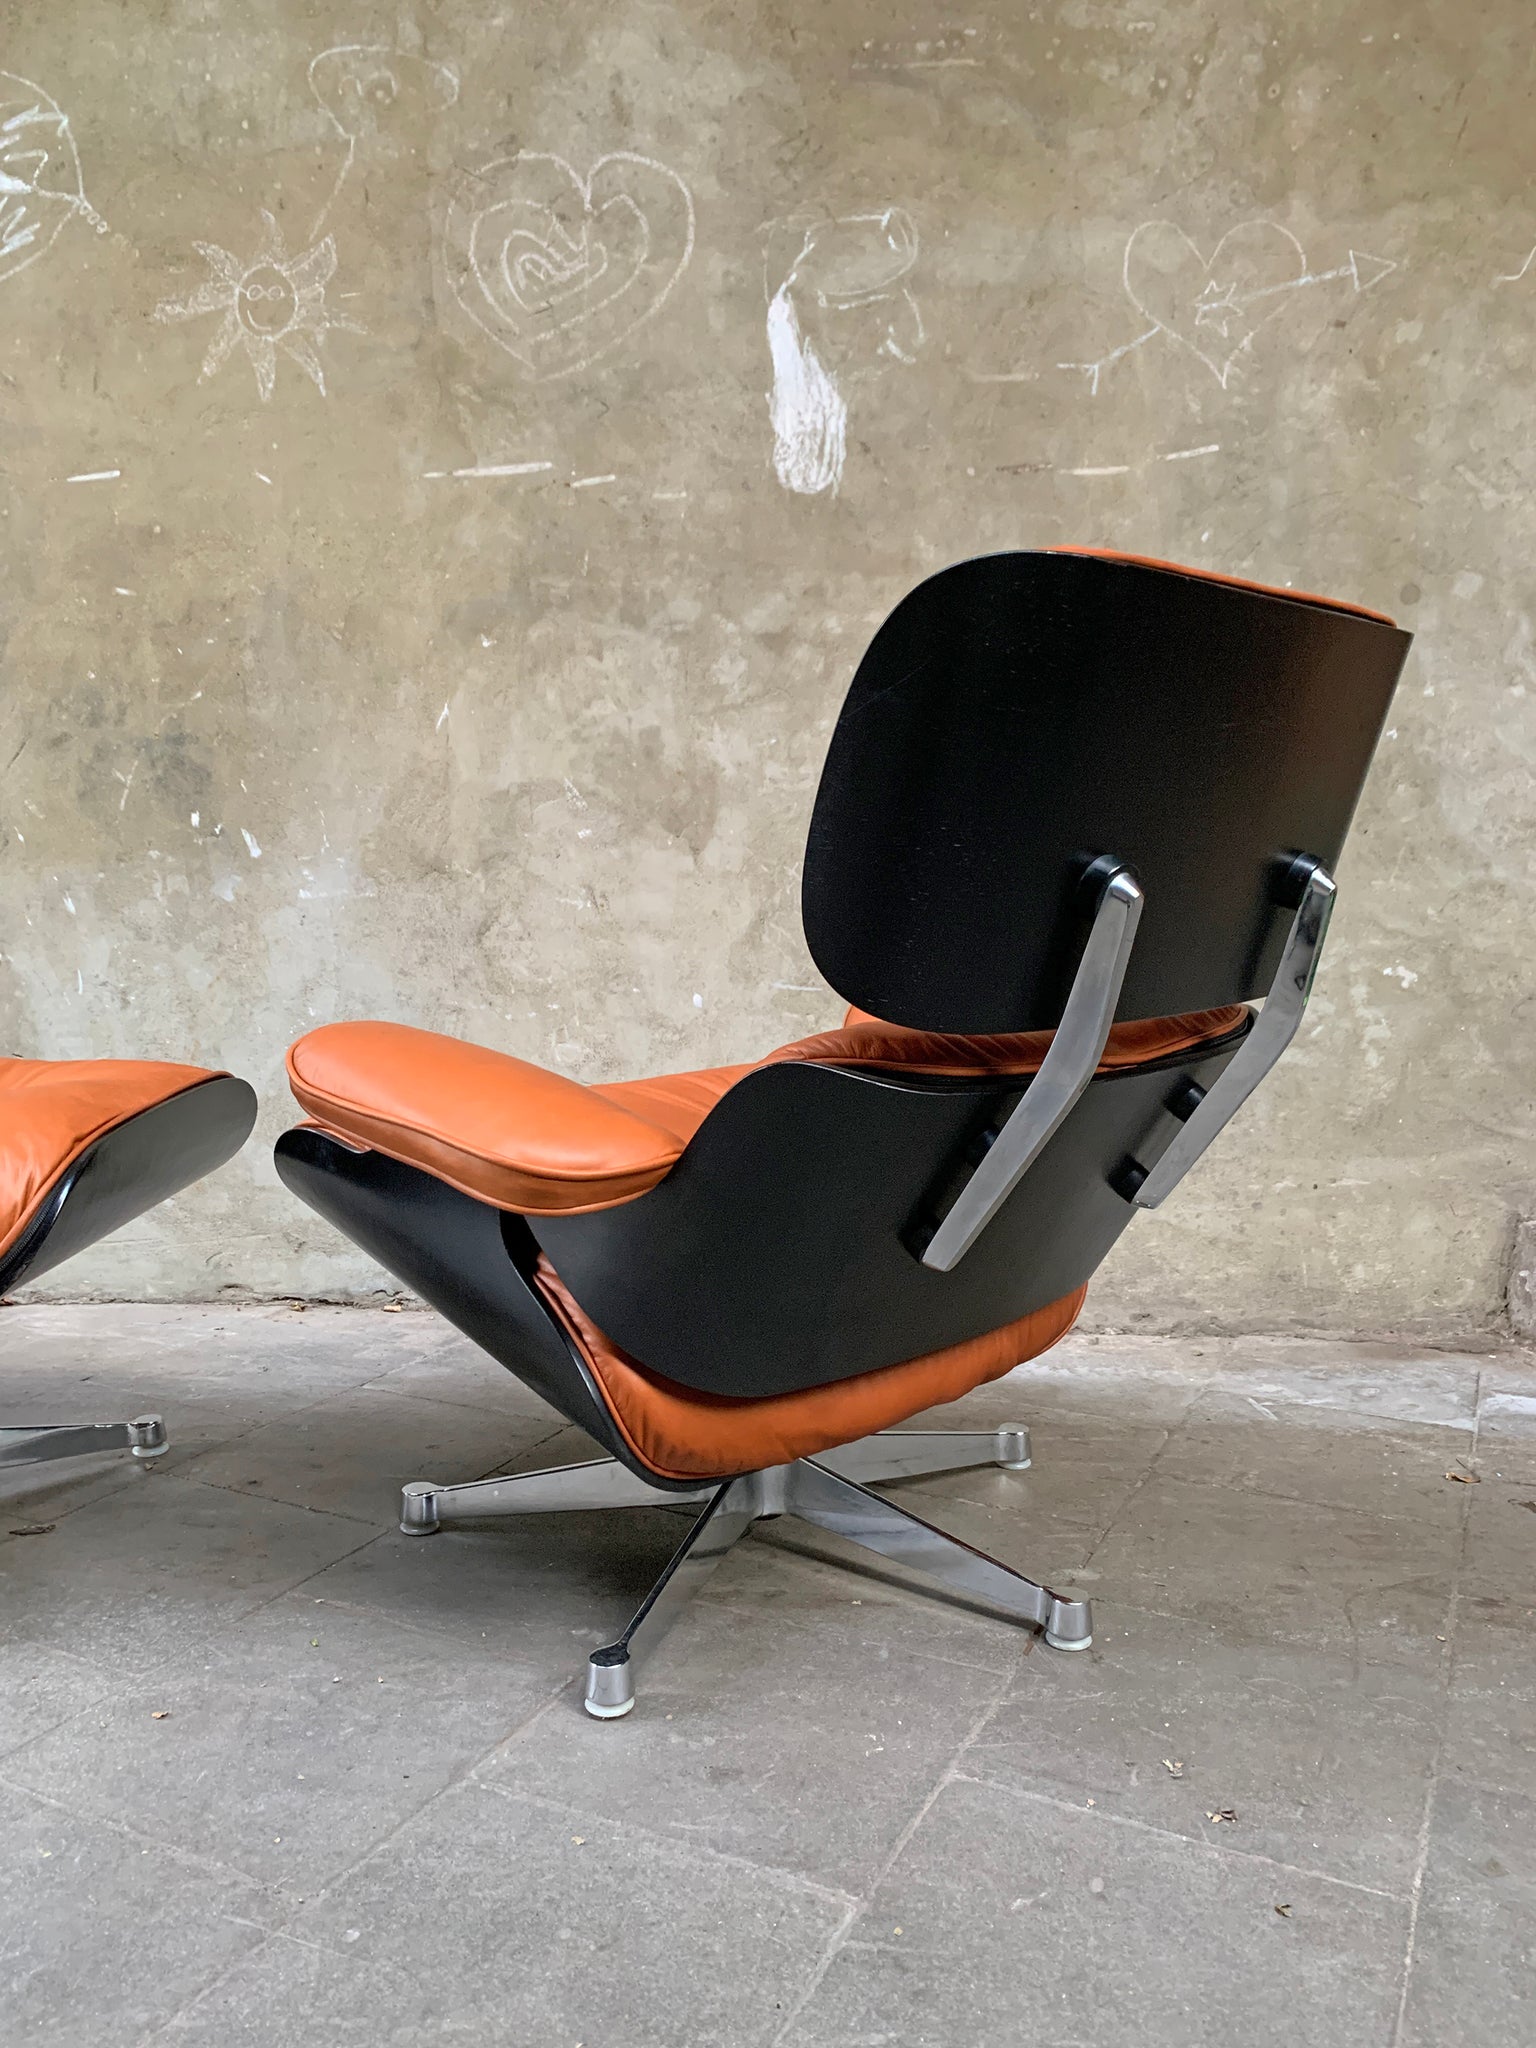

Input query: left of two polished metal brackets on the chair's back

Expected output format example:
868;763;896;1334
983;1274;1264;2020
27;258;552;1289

922;862;1143;1274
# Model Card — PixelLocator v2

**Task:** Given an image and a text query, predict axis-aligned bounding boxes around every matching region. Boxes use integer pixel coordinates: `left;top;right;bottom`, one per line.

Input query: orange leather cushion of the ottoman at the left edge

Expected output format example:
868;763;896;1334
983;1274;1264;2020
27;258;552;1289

0;1059;217;1253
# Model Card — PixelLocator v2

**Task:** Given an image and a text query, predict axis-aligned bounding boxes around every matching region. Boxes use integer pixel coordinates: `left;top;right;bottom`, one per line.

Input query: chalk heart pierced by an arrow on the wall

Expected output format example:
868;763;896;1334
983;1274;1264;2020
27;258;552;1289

1057;221;1397;393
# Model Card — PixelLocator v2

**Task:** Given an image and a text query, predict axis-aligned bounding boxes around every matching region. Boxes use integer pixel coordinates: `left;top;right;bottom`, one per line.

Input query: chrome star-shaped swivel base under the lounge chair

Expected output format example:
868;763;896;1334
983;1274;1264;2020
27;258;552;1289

399;1427;1094;1720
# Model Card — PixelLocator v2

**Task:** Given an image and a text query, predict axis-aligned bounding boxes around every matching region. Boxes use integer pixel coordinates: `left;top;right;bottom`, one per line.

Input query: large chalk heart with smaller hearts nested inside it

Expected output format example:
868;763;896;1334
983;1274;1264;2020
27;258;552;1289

444;150;694;383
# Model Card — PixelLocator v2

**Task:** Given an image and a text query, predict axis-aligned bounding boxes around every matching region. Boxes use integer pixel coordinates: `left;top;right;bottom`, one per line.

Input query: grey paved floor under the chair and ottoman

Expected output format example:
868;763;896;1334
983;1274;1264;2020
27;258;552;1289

0;1307;1536;2048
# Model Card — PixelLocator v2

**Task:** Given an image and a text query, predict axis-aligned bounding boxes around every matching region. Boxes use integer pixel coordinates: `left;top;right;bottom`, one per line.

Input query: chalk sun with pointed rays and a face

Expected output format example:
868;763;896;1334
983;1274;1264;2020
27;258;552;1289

156;209;365;401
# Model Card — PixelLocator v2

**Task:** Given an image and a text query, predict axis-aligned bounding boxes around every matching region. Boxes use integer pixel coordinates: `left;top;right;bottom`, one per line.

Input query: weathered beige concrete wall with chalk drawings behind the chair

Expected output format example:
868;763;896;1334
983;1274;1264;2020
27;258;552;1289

0;0;1536;1339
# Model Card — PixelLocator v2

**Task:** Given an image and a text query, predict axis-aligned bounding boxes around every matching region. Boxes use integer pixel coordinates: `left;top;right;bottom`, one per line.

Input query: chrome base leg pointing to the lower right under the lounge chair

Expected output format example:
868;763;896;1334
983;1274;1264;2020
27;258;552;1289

784;1458;1094;1651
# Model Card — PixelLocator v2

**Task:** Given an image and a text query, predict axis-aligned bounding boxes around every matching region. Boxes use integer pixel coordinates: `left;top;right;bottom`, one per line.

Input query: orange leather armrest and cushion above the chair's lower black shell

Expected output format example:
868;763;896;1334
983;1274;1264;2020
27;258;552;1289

289;1004;1245;1217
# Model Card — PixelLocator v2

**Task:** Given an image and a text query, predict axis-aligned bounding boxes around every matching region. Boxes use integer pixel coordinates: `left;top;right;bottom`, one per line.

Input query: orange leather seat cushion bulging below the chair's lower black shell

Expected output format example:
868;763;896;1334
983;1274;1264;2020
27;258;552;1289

535;1255;1087;1479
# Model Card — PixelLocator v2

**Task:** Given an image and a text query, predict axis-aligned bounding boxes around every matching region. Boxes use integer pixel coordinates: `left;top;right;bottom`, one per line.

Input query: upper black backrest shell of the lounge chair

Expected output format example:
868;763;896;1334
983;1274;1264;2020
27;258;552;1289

803;553;1409;1032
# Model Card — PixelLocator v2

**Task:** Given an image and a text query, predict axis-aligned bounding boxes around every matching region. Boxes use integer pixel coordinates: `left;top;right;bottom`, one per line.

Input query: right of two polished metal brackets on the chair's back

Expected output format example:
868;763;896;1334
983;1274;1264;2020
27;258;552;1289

1114;858;1337;1208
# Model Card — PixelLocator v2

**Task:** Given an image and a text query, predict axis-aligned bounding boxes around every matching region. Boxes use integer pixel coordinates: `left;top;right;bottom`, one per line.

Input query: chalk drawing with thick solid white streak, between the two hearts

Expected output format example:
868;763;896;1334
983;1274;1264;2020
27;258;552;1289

764;207;924;498
